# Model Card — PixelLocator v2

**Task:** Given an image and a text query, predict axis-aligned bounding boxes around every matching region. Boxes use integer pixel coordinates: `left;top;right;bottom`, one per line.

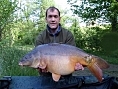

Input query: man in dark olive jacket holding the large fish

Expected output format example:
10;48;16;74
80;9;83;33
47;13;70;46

35;7;83;75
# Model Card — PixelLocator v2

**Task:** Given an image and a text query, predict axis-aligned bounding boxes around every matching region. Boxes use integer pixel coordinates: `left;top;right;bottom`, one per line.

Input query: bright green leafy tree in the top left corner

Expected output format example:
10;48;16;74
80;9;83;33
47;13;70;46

0;0;17;41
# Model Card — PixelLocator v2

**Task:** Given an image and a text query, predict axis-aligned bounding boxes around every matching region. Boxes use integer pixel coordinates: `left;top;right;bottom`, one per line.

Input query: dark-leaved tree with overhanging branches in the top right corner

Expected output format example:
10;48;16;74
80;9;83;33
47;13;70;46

68;0;118;31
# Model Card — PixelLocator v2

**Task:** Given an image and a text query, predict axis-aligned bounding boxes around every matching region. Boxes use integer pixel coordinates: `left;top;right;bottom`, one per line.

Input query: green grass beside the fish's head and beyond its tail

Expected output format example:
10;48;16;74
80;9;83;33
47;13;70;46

0;46;118;77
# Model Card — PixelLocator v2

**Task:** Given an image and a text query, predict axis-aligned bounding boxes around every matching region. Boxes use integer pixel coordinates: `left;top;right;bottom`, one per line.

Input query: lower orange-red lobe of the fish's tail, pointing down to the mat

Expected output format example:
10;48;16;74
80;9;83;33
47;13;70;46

87;63;103;82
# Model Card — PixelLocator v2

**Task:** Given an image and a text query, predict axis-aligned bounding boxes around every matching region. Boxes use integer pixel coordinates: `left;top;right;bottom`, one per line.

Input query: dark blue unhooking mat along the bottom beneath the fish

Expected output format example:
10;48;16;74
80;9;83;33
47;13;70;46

0;75;118;89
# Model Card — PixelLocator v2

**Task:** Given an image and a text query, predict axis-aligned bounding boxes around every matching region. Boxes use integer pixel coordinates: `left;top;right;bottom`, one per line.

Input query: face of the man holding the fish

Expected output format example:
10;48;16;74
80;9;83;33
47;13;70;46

46;9;60;30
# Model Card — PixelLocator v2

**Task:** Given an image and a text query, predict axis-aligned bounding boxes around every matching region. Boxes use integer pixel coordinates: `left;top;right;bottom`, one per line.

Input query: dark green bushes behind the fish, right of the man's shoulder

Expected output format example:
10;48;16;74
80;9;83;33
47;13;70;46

73;27;109;51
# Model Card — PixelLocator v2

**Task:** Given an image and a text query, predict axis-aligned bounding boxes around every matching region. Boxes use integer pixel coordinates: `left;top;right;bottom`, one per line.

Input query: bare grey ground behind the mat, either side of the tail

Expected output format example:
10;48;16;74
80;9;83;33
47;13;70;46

73;64;118;77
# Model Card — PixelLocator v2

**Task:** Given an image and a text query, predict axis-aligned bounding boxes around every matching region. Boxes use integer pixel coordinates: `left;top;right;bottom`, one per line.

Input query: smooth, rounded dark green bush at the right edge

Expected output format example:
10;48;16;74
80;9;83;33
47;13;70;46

100;32;118;57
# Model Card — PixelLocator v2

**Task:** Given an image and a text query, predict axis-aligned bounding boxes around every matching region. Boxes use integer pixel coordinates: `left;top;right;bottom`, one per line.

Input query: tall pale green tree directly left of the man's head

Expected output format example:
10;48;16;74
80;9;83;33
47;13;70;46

15;0;54;45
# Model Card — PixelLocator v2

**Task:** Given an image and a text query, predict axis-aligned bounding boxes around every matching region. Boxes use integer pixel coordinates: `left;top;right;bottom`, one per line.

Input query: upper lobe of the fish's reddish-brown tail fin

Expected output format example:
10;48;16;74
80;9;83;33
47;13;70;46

93;56;109;69
